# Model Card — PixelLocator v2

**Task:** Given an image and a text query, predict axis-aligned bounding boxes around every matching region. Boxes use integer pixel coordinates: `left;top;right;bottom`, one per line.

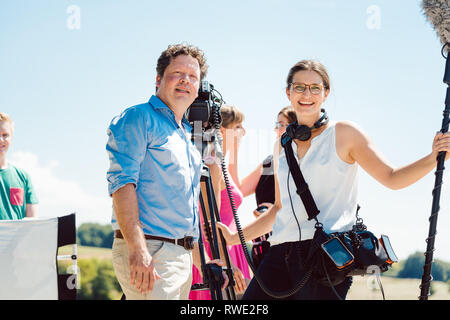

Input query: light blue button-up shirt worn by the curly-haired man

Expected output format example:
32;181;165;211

106;96;202;240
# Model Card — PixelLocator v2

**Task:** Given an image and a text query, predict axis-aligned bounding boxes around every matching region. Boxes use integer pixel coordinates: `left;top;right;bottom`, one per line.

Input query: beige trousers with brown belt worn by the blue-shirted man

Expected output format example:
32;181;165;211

112;238;192;300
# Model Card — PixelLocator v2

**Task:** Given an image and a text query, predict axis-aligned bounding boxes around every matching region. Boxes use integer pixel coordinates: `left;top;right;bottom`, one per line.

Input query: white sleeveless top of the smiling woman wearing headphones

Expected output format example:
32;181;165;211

269;121;358;245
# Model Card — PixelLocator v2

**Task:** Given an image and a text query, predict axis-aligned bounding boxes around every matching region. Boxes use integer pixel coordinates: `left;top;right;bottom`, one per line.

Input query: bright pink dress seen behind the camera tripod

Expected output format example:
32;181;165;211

189;177;250;300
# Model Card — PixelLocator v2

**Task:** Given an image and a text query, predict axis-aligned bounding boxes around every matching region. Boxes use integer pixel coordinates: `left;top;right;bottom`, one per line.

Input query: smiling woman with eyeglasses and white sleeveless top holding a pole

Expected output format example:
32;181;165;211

214;60;450;300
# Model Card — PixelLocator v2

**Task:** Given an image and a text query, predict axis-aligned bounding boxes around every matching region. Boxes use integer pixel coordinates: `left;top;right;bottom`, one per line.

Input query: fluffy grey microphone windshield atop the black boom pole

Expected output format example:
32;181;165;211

422;0;450;52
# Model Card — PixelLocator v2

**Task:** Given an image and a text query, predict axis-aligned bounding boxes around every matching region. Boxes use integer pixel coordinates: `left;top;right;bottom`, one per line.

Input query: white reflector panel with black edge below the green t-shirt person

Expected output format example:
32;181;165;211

0;218;58;300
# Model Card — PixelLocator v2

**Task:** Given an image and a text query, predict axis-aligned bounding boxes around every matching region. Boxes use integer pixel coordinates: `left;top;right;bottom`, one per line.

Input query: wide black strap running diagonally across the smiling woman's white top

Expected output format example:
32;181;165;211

281;133;320;220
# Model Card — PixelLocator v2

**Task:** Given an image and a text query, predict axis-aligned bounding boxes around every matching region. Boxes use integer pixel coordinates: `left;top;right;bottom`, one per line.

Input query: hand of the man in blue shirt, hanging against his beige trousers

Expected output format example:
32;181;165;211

128;249;161;294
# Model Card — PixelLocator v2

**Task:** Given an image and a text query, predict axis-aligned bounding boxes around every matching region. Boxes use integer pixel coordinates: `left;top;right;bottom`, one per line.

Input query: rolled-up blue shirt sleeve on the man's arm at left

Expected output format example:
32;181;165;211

106;107;148;195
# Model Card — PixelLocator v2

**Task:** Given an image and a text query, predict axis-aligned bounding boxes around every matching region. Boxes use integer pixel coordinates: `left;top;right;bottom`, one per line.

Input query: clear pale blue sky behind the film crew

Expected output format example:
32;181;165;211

0;0;450;260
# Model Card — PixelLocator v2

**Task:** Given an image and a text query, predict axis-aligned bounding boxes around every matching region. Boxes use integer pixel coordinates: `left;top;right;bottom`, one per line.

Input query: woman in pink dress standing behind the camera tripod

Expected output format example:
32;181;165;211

189;105;251;300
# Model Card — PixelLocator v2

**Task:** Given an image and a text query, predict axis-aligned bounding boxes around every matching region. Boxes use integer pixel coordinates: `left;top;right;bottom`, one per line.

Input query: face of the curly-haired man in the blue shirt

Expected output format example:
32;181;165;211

156;55;200;112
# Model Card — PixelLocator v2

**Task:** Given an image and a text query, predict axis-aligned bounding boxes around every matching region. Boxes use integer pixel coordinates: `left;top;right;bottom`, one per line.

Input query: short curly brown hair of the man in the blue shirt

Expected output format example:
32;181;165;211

156;43;208;80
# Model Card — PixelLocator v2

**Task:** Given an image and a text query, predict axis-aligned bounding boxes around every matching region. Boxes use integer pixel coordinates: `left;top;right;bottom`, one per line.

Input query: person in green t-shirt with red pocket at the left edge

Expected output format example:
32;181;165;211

0;112;38;220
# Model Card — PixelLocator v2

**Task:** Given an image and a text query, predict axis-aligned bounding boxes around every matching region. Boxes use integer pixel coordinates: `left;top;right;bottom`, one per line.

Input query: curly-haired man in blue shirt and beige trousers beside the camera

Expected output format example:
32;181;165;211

106;44;225;300
